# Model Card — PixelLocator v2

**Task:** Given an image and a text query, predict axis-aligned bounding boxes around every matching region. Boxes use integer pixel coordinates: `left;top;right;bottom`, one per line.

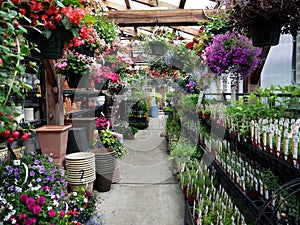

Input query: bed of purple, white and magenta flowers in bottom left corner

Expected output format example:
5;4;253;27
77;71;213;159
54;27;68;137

0;153;67;225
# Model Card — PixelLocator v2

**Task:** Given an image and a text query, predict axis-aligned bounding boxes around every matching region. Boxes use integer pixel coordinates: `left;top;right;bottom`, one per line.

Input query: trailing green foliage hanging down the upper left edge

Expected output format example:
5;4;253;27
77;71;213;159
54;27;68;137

0;1;36;133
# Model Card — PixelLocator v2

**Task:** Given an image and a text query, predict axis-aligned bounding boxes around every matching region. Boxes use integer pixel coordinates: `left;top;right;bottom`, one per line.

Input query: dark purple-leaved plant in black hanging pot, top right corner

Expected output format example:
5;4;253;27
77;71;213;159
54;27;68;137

224;0;300;47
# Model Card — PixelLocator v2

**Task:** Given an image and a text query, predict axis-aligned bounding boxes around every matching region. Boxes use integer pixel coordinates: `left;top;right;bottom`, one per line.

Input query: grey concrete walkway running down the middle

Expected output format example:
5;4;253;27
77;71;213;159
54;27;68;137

99;115;184;225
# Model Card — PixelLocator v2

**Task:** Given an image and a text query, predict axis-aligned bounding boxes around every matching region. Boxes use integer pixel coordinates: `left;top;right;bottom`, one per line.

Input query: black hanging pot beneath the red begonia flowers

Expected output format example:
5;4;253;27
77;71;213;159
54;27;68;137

27;30;64;59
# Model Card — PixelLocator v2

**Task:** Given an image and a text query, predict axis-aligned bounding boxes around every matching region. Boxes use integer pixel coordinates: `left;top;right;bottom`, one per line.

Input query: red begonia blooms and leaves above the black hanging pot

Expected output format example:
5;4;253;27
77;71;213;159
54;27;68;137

12;0;91;43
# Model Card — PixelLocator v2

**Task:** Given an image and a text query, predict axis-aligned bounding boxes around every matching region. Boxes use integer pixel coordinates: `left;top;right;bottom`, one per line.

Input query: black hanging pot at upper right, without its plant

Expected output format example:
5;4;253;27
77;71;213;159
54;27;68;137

250;19;281;47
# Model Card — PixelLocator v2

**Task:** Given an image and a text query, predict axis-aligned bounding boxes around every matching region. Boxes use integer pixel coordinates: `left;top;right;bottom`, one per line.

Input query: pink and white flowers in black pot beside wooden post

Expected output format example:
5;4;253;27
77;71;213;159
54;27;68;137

54;51;95;88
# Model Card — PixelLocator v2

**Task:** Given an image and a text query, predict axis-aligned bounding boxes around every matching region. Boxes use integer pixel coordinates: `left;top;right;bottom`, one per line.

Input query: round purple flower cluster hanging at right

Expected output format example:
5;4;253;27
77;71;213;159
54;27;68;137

202;31;262;78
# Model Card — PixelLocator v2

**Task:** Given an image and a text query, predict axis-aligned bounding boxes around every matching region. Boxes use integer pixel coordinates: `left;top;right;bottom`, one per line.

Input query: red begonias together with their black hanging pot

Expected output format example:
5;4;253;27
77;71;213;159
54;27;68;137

14;0;92;59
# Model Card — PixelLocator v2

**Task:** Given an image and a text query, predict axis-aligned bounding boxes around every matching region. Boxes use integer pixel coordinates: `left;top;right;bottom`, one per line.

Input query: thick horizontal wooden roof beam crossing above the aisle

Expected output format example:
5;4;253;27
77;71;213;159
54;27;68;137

107;9;214;27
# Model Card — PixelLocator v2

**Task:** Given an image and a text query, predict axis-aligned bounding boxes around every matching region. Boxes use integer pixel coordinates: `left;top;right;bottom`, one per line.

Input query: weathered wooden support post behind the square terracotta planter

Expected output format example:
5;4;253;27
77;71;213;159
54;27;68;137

42;59;64;125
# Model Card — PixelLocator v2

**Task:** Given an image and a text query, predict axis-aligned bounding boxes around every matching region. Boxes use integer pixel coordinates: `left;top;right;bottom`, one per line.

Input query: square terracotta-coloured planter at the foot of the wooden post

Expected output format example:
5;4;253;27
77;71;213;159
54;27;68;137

35;125;71;166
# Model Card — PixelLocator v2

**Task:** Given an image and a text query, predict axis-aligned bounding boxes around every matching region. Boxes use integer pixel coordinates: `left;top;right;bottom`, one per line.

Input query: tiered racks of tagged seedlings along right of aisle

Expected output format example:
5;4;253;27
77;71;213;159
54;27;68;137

166;81;300;224
